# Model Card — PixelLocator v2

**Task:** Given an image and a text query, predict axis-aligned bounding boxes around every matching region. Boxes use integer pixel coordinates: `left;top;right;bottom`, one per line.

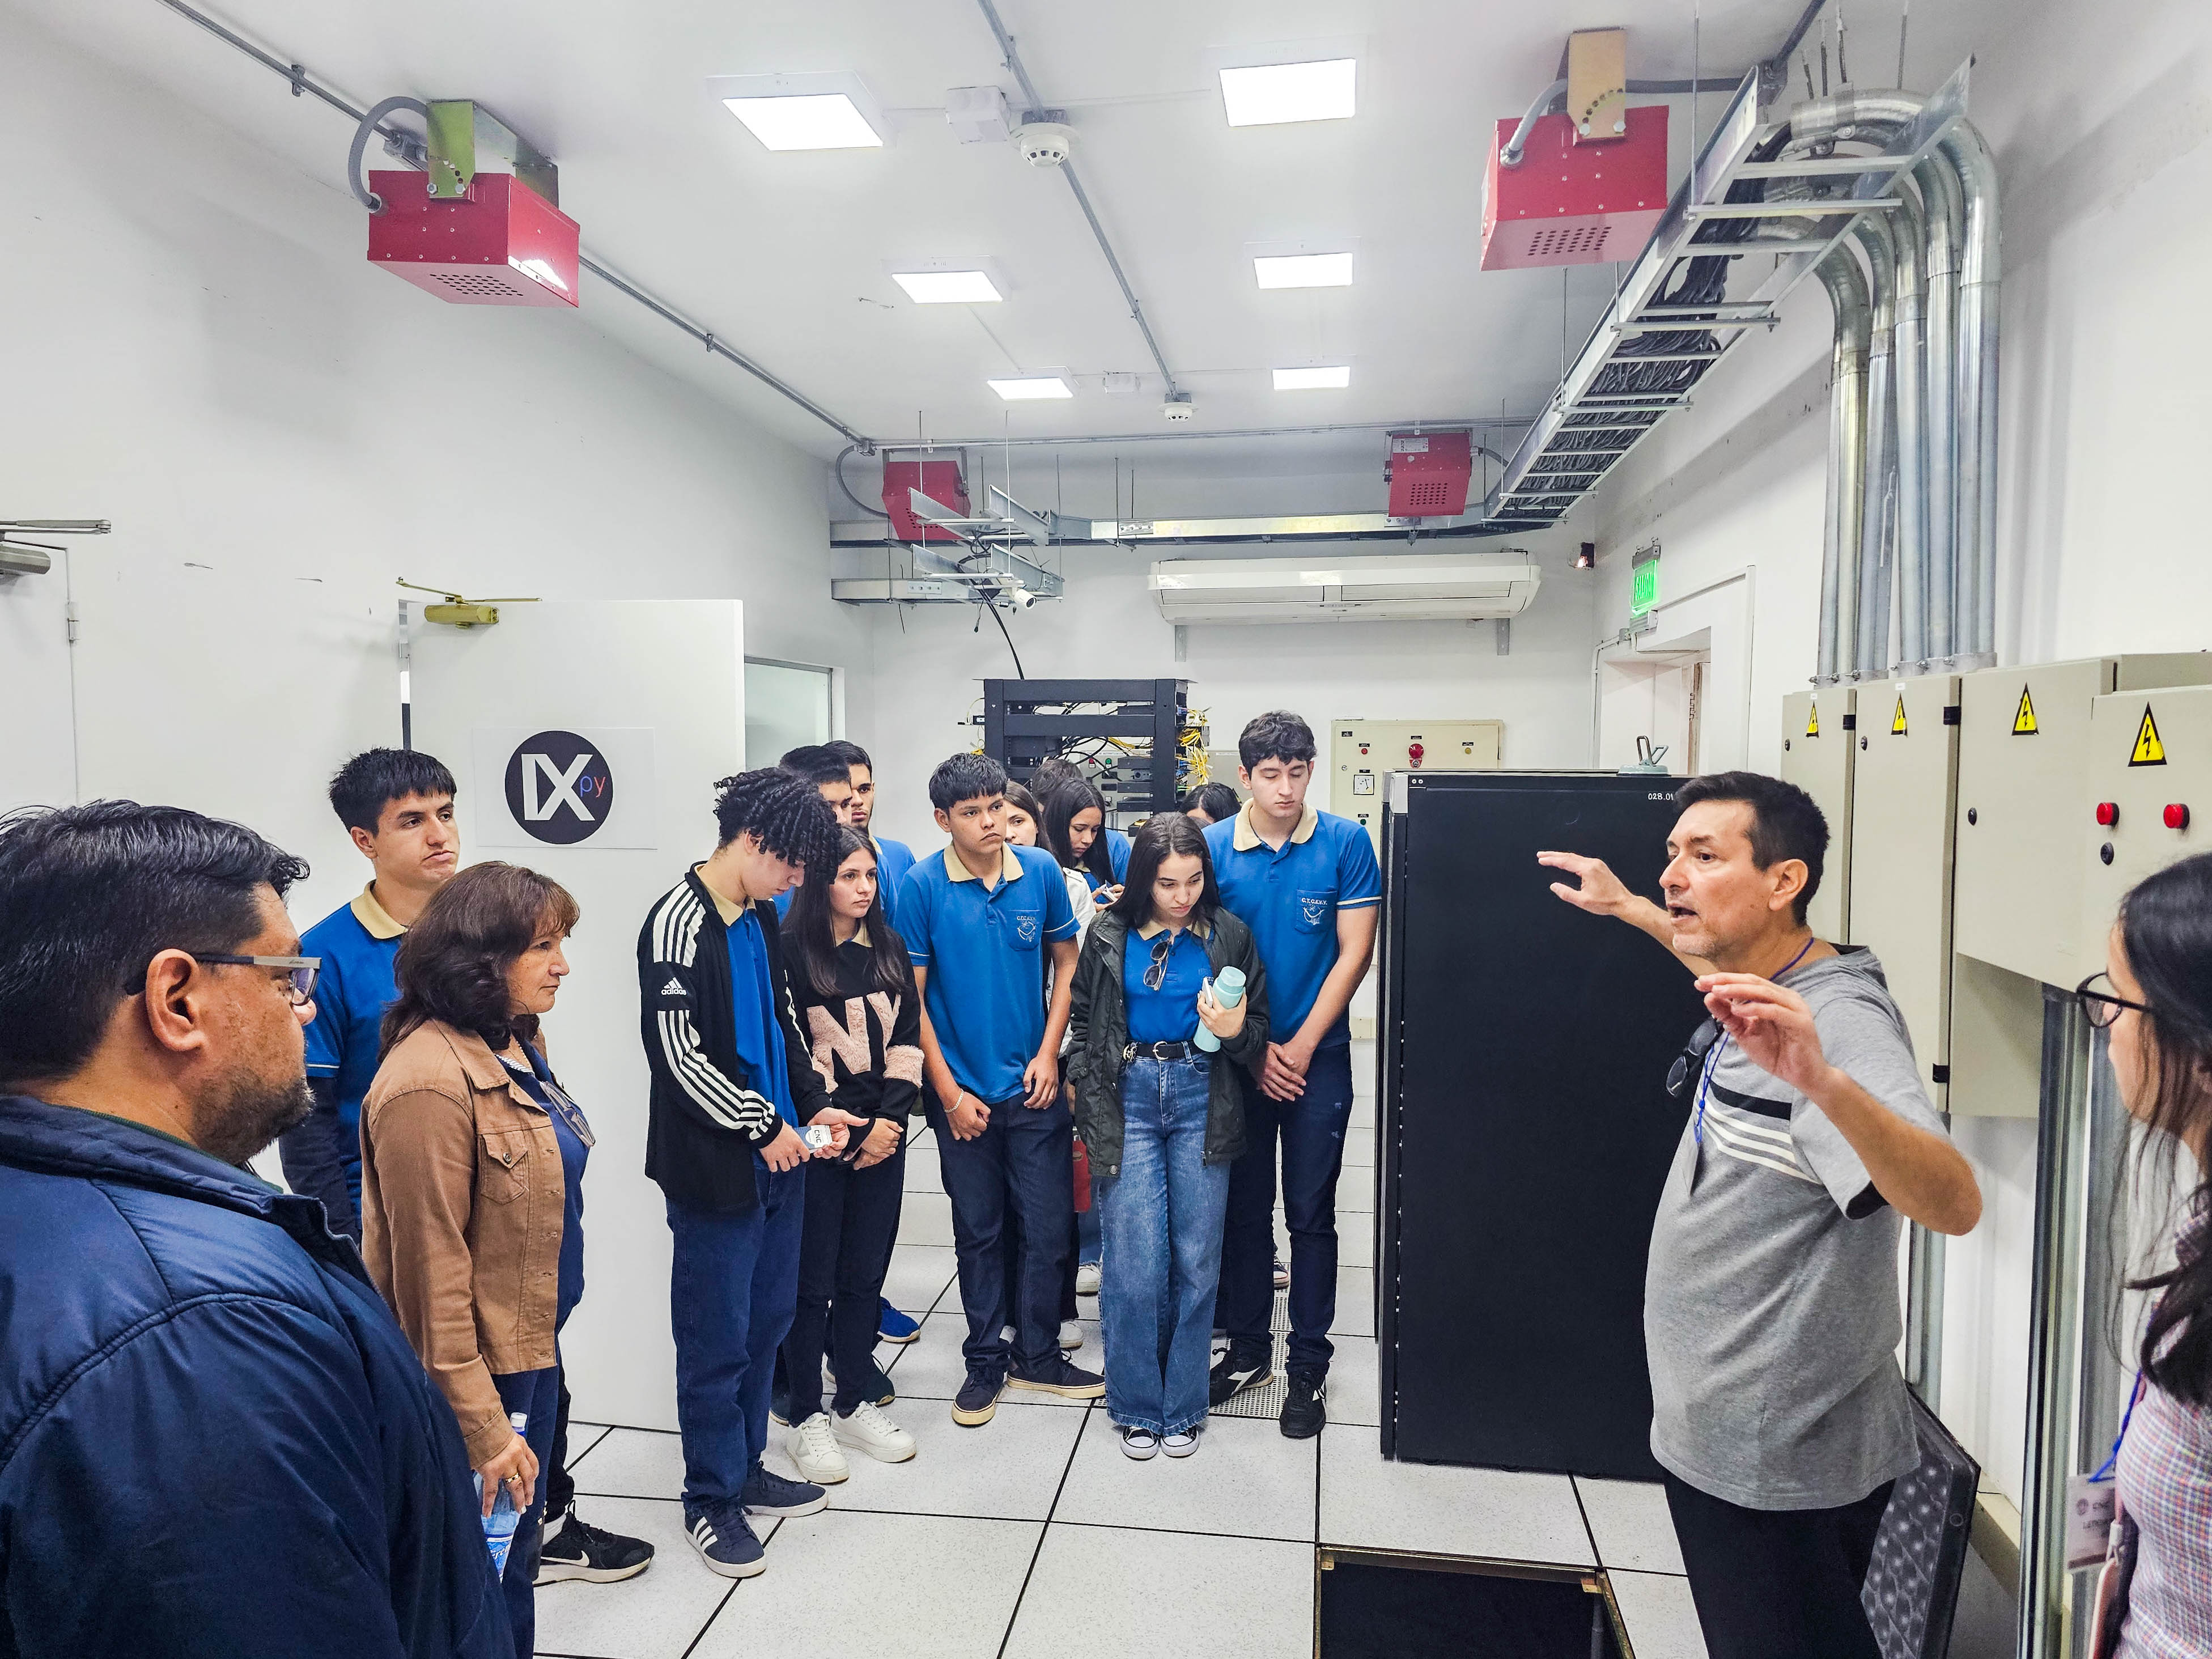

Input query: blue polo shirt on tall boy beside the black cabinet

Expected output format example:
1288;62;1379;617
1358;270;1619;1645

1205;801;1382;1049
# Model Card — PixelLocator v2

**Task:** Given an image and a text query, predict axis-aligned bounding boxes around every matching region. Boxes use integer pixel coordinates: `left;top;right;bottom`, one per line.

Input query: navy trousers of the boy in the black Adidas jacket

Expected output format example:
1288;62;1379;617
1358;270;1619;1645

668;1155;808;1520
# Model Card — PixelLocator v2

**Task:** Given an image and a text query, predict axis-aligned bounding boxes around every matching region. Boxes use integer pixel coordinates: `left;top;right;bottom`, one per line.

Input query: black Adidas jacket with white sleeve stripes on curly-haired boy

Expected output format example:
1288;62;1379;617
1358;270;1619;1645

637;869;830;1215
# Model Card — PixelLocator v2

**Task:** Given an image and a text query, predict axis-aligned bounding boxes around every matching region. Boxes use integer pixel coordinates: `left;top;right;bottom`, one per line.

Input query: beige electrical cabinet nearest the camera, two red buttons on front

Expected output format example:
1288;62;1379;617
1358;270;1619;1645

2060;686;2212;978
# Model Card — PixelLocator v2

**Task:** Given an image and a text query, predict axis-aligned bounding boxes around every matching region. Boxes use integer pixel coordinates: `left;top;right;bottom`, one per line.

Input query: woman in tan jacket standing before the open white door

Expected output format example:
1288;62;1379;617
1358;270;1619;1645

360;863;591;1659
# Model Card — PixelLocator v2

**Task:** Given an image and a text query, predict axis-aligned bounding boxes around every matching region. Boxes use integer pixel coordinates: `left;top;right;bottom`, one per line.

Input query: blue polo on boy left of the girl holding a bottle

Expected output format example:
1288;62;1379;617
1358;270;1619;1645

898;849;1075;1106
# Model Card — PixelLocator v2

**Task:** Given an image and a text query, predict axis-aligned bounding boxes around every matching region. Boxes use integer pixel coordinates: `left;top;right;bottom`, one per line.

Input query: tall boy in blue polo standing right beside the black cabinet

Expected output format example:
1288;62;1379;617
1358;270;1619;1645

1205;710;1382;1440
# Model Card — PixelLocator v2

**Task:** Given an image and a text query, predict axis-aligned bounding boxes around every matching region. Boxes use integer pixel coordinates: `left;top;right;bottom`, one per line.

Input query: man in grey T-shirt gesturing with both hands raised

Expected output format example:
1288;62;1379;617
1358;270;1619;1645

1538;772;1982;1659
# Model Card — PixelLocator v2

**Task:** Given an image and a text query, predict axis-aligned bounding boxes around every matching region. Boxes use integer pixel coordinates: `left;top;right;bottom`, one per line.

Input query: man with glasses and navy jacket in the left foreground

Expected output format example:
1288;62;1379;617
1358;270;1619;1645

0;801;513;1659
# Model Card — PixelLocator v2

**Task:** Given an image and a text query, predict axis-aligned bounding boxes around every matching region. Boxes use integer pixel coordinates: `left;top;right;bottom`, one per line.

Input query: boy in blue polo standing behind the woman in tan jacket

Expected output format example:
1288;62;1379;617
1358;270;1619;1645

277;750;460;1243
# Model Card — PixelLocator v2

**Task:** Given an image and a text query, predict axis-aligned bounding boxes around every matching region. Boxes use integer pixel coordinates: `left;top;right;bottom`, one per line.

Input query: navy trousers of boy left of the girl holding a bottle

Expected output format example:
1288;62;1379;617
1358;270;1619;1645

929;1097;1075;1376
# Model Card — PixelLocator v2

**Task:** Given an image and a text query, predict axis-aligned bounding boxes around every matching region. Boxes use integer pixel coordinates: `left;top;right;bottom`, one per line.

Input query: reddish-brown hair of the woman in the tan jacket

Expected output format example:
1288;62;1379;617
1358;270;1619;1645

378;860;578;1055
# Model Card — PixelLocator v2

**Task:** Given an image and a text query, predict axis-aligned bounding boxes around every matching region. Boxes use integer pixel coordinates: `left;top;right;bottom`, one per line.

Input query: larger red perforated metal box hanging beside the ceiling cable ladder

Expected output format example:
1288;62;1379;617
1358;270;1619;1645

1482;104;1668;270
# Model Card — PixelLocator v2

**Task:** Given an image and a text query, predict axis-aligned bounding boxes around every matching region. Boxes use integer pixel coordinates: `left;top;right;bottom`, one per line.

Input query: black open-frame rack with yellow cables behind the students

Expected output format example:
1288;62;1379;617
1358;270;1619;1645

982;679;1190;823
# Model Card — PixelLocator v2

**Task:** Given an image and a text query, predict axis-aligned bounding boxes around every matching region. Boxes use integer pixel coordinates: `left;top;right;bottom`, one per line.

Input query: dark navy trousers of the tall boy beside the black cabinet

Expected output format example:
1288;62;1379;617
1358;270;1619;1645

1221;1042;1352;1372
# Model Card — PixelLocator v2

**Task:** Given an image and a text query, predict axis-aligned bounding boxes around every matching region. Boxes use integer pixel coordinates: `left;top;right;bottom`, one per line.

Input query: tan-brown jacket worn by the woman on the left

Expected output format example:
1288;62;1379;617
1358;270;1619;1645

360;1022;564;1465
